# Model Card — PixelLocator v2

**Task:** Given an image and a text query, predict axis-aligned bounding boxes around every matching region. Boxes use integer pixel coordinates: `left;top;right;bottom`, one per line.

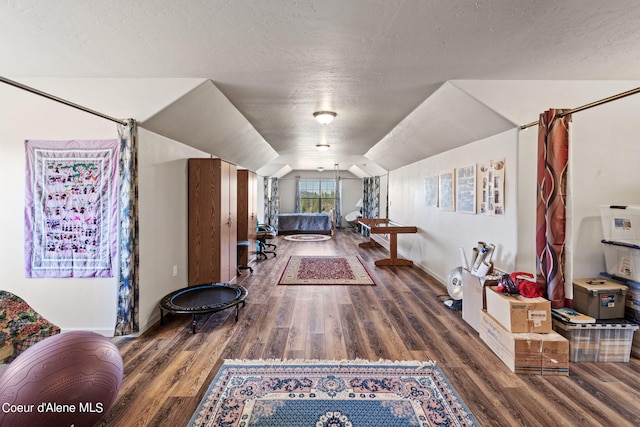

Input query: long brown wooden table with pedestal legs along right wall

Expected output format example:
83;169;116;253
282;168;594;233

356;218;418;267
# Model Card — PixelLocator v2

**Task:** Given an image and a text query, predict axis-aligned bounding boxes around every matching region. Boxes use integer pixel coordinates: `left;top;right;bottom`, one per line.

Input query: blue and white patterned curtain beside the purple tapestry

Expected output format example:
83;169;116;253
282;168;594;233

114;119;140;336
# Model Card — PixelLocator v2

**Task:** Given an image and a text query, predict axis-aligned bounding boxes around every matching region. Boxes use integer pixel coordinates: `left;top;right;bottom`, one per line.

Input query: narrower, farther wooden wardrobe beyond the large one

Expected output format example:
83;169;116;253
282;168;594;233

238;169;258;266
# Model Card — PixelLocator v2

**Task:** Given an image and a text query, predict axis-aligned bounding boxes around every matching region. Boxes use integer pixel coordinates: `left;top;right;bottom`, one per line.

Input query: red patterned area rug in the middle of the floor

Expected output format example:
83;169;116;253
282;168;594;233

278;256;375;285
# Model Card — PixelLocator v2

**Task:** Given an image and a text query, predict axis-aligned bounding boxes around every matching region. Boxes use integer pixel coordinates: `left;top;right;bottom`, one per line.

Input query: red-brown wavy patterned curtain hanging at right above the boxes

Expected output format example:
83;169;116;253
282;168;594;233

536;109;571;308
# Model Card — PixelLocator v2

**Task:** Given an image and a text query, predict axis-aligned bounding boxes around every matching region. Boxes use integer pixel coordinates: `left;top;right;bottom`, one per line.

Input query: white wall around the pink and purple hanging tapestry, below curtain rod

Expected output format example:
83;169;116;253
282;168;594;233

0;85;118;335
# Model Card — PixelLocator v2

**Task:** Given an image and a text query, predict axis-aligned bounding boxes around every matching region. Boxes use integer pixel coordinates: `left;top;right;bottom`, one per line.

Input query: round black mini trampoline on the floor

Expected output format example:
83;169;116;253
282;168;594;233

160;283;247;334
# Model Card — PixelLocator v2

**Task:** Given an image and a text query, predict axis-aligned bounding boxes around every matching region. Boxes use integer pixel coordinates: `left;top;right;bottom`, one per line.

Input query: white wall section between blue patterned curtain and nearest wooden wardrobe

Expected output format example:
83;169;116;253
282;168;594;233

138;129;210;331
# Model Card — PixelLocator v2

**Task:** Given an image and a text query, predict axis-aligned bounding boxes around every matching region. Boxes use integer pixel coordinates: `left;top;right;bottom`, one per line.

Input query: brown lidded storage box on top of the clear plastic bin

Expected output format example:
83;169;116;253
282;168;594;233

573;279;629;319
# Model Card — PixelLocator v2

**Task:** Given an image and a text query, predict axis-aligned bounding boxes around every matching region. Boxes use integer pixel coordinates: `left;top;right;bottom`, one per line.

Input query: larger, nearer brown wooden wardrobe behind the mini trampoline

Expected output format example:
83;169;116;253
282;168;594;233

188;159;238;286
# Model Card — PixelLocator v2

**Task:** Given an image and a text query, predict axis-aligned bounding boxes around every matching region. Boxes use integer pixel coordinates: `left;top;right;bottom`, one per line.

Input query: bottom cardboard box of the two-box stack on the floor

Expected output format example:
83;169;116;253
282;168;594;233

479;310;569;376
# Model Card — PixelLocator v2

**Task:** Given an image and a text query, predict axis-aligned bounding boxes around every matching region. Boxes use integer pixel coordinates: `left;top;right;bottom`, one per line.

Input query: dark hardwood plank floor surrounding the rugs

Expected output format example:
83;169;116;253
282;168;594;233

98;230;640;427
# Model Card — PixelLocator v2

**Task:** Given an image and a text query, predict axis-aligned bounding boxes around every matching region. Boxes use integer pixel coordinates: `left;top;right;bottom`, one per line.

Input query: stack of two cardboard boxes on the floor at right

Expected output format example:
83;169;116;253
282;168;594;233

479;287;569;376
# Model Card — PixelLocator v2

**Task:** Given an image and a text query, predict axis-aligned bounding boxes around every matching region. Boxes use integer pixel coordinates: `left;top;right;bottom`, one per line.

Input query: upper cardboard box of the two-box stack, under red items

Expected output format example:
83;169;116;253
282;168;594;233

486;286;553;334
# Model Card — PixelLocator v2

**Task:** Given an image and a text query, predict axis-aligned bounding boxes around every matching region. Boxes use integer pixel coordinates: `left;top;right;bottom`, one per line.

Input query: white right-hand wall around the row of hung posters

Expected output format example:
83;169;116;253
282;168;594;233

389;130;518;283
